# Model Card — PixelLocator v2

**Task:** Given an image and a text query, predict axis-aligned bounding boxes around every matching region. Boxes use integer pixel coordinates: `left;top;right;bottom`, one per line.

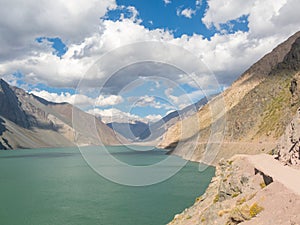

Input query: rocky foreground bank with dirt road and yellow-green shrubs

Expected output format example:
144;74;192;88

169;155;300;225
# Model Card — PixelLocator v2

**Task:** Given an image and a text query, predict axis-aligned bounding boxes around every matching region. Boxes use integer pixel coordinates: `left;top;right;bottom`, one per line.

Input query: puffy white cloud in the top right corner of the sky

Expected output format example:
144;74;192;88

202;0;300;41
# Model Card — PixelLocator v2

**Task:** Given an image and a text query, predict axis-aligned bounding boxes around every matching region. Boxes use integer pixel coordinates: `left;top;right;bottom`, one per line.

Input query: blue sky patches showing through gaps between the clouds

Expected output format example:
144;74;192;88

28;0;241;121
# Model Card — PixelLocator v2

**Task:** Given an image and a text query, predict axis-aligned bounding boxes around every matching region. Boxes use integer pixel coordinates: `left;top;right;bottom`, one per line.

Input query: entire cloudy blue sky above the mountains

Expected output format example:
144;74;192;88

0;0;300;122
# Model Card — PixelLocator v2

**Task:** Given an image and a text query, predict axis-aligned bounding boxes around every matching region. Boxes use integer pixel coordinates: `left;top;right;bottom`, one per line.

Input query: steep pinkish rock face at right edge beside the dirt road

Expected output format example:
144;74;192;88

276;108;300;168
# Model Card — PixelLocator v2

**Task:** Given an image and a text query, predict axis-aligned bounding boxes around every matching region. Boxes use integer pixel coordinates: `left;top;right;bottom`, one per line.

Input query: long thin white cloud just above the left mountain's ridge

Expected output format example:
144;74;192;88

30;90;123;107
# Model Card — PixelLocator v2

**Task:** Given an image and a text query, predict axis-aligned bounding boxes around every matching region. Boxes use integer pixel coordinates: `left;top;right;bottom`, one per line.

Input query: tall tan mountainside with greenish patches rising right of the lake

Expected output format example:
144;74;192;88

160;32;300;162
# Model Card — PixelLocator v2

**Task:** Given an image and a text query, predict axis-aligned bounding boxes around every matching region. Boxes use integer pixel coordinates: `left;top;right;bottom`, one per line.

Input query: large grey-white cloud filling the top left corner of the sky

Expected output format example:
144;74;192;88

0;0;116;61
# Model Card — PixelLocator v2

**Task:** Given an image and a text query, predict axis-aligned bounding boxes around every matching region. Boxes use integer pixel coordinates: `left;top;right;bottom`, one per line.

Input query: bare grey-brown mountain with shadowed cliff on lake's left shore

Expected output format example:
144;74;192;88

0;79;124;149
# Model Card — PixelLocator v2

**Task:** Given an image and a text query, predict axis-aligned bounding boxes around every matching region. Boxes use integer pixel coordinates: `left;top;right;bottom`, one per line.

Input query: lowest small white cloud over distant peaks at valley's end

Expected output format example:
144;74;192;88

88;108;161;123
